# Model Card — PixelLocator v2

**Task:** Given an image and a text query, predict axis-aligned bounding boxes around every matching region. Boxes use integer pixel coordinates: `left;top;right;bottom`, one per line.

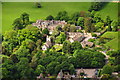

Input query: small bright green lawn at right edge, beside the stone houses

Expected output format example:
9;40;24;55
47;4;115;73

102;32;118;50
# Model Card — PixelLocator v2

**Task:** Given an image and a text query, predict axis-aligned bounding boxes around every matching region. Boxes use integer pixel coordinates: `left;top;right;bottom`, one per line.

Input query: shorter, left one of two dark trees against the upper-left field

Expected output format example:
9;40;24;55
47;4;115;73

12;18;24;30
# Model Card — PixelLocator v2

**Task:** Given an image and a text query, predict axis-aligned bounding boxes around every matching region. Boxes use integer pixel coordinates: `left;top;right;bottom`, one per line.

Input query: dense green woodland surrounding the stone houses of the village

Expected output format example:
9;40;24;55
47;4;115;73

0;3;120;80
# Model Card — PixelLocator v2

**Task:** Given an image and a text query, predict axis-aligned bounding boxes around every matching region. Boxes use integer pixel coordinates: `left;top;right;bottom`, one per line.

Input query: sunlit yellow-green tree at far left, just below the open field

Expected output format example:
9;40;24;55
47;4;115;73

2;30;18;56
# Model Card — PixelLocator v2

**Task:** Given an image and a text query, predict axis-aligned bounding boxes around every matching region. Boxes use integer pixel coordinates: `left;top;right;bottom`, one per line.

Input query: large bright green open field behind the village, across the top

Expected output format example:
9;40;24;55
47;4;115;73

2;2;117;32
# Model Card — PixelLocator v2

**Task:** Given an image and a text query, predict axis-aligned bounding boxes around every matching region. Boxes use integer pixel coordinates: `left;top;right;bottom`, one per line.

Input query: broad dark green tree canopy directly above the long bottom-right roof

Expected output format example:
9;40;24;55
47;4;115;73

73;49;105;68
